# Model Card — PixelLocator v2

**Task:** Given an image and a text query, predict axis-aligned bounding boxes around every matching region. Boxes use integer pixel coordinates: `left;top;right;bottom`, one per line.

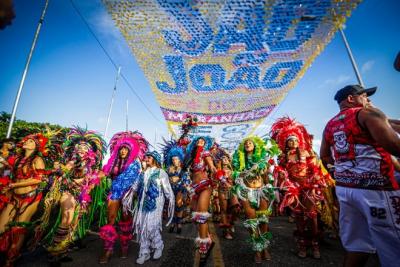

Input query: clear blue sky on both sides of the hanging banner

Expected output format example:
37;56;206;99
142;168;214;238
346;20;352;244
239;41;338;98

0;0;400;151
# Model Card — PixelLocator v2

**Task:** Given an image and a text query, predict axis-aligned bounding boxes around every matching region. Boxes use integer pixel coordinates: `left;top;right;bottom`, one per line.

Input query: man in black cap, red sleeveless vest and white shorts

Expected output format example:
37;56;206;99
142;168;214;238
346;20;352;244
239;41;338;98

320;85;400;266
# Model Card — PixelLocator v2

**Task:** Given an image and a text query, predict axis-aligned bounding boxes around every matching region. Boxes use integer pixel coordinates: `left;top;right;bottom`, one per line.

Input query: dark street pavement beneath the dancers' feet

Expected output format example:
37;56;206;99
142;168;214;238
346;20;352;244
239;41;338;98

16;217;379;267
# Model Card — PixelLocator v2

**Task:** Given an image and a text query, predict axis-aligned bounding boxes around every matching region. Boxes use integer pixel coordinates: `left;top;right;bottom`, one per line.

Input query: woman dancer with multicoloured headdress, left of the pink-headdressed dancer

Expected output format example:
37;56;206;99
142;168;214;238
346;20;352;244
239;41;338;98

41;127;105;265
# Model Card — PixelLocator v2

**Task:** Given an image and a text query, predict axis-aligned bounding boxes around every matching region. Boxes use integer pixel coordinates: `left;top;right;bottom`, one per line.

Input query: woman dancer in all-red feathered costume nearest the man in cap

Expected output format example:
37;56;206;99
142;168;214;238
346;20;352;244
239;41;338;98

270;117;326;259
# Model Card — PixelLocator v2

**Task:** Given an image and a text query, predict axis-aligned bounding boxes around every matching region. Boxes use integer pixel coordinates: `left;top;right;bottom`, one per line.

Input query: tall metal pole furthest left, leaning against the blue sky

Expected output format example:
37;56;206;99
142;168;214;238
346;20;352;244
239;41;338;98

7;0;49;138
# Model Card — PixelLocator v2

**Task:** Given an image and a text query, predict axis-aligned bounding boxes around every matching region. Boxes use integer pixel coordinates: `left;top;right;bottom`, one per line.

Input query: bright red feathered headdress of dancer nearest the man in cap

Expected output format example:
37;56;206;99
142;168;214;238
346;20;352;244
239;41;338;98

270;117;311;151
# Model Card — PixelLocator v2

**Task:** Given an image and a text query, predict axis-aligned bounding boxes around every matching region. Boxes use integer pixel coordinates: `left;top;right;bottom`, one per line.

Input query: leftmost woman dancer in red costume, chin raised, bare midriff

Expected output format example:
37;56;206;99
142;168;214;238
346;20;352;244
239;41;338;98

0;133;48;266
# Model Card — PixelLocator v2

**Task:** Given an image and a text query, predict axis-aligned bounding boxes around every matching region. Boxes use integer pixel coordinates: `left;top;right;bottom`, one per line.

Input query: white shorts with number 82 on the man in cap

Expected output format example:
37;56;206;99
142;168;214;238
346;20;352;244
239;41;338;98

336;186;400;267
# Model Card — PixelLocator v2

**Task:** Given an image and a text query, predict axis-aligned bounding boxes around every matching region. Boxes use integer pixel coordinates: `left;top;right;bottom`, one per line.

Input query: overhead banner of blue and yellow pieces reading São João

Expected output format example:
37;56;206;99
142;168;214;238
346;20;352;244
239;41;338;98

103;0;361;151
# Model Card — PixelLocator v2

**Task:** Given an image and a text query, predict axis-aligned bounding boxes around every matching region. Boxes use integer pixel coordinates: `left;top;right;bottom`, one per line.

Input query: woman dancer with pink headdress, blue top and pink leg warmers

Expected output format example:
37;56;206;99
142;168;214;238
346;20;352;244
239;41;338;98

99;131;148;263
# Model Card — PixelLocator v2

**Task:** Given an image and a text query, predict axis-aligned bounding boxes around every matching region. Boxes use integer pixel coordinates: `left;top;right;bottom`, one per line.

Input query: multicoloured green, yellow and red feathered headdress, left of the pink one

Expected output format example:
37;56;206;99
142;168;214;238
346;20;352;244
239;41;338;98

63;126;106;167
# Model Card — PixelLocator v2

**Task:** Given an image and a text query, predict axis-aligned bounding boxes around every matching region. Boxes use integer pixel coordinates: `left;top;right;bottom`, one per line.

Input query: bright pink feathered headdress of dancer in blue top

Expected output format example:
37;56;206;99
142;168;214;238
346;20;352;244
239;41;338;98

103;131;148;174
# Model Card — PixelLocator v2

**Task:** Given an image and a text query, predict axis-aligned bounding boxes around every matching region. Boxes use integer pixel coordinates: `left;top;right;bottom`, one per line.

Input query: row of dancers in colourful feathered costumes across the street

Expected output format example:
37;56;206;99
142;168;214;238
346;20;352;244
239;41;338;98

0;115;337;266
